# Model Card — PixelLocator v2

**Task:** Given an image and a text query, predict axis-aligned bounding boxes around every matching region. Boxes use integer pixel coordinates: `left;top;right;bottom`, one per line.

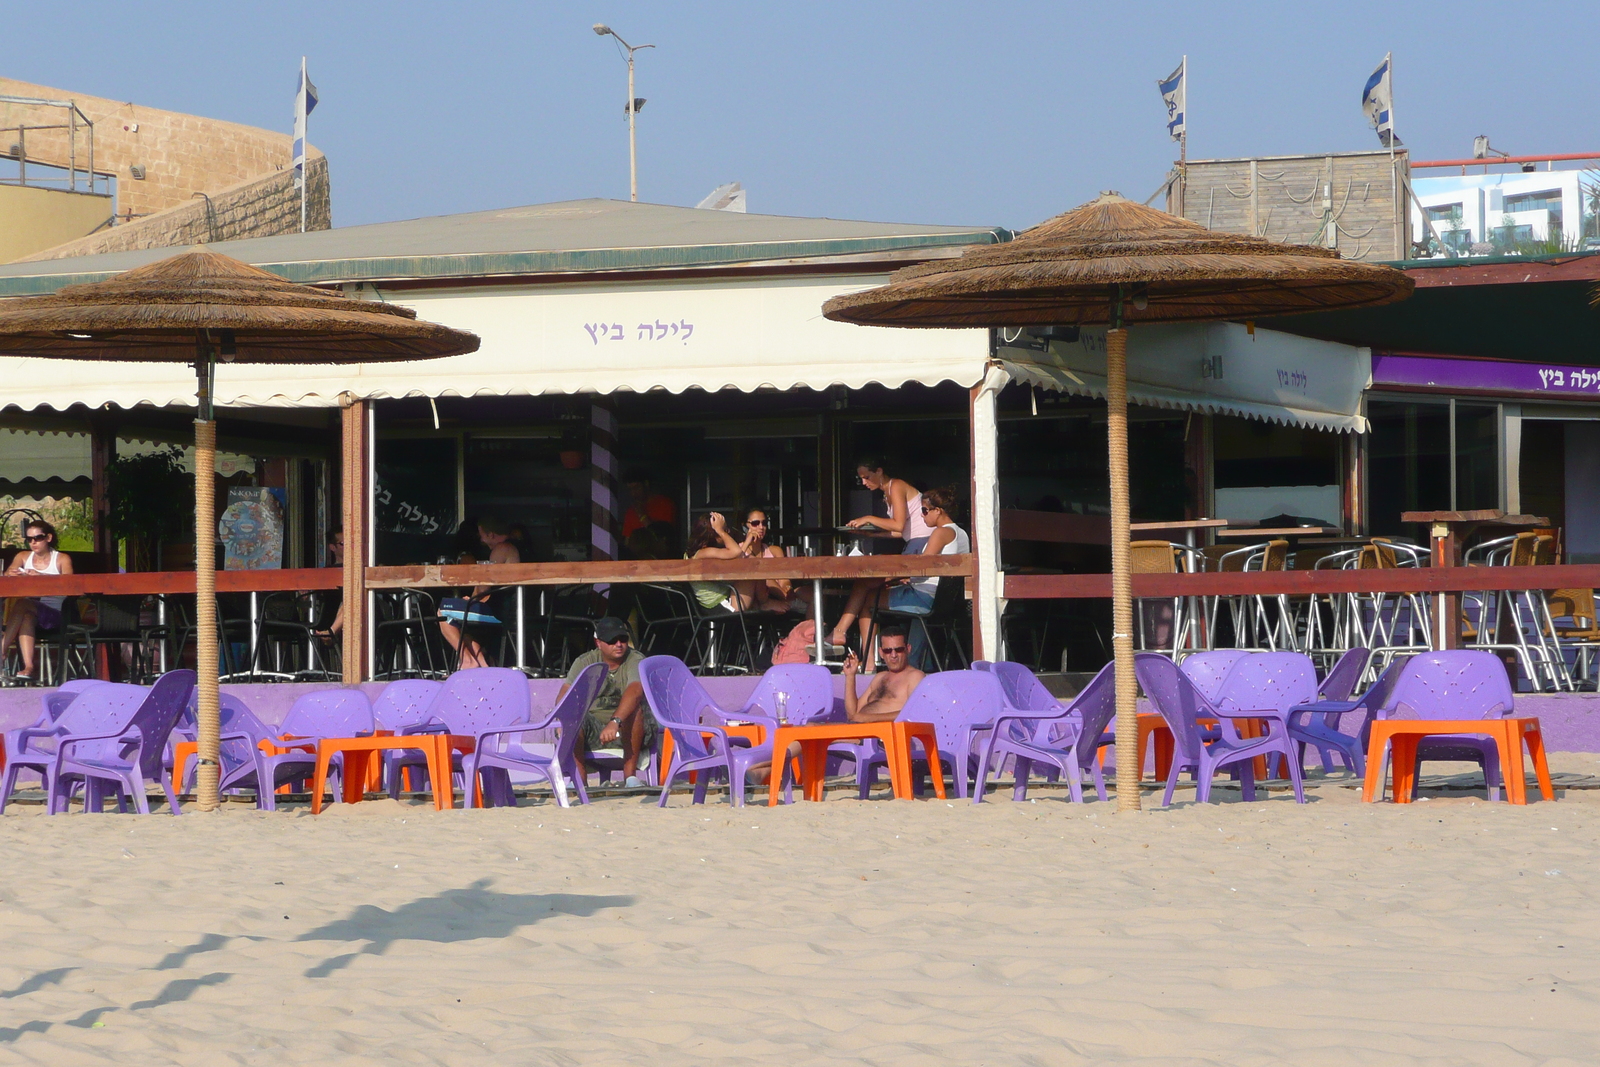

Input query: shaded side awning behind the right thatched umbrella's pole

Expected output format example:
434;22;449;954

998;323;1371;434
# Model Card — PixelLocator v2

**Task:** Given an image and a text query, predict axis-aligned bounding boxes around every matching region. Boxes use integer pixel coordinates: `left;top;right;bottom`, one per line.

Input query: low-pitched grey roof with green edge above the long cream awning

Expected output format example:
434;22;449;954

0;198;1010;296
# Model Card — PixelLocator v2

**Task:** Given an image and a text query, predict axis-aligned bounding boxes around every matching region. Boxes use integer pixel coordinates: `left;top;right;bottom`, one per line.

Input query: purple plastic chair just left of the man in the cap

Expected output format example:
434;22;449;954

466;664;606;808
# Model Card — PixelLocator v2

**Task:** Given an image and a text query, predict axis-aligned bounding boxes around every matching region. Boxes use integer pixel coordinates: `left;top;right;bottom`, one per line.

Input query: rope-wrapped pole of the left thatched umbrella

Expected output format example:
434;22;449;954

195;348;221;811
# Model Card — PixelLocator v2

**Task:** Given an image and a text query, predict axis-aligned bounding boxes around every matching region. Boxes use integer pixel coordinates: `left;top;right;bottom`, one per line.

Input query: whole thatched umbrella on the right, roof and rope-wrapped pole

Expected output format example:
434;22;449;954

822;194;1413;811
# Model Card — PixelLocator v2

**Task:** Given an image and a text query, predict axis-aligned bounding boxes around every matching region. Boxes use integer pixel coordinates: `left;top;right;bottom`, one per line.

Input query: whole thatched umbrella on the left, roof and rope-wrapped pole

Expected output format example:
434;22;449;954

0;248;478;811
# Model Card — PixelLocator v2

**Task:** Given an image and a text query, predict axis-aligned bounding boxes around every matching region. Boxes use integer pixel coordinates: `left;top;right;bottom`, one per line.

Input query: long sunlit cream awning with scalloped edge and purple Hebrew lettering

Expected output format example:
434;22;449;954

0;275;989;410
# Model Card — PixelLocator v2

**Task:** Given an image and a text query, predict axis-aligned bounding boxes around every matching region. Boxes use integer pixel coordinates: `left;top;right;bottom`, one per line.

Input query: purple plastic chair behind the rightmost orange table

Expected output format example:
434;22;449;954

1378;649;1523;800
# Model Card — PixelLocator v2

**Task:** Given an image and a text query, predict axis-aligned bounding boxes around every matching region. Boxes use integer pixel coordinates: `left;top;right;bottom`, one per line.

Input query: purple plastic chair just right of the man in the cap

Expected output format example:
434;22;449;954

638;656;778;808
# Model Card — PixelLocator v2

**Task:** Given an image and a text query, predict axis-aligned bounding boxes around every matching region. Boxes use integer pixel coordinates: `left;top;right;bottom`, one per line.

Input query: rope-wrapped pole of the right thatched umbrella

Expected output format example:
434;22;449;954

1106;328;1142;813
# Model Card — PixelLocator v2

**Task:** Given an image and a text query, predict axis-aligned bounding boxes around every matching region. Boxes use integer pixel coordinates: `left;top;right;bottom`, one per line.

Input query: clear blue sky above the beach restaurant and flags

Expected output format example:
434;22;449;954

12;0;1600;227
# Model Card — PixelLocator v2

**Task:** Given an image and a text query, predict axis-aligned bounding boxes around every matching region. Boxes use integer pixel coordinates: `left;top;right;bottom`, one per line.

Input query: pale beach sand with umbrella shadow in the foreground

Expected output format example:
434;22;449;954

0;755;1600;1067
